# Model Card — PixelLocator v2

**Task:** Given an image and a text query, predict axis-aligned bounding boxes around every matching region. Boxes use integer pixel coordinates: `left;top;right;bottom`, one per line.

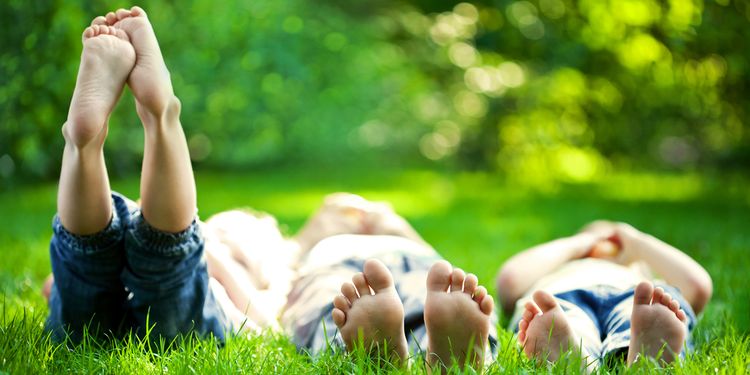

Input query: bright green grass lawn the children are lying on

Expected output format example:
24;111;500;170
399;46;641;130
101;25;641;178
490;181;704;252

0;169;750;374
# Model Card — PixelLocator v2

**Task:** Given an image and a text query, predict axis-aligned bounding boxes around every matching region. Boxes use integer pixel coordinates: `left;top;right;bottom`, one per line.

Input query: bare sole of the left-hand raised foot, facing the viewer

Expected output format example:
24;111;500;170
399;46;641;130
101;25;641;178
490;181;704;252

63;25;135;148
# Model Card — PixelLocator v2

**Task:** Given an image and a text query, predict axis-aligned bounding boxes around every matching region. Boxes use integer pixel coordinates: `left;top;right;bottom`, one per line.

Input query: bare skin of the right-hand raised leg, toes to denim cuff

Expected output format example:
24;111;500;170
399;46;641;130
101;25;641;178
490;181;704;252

103;7;196;232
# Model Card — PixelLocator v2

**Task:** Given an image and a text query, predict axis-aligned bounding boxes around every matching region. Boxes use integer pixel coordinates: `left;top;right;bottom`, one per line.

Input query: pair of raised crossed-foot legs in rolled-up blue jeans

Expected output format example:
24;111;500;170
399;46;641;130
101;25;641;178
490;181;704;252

46;7;228;346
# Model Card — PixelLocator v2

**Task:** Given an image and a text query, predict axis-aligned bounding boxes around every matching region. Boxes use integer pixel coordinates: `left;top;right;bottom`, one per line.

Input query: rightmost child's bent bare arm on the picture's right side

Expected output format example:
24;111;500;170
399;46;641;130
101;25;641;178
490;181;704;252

615;223;713;314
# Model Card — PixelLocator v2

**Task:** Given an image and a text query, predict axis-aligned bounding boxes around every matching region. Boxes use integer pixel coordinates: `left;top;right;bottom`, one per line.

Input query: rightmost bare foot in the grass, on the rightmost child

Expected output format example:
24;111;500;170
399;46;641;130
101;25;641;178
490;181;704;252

628;281;687;365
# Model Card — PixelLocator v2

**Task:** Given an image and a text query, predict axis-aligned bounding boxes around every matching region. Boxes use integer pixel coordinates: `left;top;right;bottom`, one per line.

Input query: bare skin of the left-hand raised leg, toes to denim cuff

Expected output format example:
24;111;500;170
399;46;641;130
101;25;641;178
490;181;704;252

57;25;135;235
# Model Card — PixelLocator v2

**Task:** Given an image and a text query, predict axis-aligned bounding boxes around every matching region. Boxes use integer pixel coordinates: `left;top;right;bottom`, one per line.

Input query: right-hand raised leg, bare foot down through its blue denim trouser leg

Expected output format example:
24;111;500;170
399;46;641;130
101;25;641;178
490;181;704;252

102;7;229;339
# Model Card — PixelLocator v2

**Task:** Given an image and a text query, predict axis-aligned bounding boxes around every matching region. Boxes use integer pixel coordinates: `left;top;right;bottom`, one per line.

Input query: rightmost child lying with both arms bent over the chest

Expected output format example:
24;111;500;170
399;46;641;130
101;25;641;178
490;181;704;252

497;221;712;368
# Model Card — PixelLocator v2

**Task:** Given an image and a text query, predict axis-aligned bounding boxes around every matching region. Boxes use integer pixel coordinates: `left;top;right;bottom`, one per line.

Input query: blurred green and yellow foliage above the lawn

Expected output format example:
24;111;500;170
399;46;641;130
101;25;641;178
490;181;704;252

0;0;750;185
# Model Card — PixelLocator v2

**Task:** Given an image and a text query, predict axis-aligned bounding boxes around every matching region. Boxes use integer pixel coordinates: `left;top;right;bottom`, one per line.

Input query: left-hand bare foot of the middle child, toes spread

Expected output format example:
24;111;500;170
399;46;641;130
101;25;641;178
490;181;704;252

332;259;408;364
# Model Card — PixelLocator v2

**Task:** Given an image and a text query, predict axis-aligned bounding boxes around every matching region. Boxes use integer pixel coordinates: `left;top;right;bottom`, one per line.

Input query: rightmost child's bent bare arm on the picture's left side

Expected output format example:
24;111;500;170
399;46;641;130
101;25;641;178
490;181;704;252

496;233;601;314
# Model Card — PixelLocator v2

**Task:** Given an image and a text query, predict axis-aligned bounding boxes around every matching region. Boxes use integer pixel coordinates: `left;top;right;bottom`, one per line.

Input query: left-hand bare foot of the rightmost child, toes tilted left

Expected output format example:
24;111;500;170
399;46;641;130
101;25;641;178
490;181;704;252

518;290;580;362
